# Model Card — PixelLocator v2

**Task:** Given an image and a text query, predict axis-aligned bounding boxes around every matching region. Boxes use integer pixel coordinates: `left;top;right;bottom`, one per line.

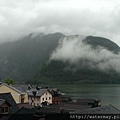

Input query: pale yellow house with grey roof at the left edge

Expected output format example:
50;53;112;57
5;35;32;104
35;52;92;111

0;83;28;103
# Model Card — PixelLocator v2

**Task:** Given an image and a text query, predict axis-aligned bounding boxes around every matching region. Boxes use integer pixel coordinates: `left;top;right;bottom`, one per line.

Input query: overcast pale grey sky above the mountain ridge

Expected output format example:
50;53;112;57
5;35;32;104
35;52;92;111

0;0;120;45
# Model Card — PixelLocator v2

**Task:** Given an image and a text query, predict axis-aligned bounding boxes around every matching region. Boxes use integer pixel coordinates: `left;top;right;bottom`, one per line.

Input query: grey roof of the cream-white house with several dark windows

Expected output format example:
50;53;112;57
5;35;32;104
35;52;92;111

28;89;50;97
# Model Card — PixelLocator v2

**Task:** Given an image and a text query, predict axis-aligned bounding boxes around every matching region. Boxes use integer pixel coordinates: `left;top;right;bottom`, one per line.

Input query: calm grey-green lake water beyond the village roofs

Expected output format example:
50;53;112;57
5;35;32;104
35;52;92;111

53;84;120;109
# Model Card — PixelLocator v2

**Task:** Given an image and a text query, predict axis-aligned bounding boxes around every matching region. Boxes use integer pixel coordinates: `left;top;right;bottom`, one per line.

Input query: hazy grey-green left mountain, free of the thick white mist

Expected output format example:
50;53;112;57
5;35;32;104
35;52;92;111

0;33;64;81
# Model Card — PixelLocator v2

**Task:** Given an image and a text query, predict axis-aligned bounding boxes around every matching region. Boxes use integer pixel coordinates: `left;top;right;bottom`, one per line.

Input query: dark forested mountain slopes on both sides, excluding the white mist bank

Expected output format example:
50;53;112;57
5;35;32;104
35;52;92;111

0;33;120;83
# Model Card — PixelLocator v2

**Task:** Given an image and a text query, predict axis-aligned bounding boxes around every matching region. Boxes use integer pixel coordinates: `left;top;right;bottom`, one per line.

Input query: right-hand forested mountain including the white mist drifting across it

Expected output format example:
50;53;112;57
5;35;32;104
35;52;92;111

39;35;120;83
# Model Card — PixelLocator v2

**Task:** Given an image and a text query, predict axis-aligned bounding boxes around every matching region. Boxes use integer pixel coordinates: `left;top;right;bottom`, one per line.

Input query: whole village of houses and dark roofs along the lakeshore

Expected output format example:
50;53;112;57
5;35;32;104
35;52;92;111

0;83;120;120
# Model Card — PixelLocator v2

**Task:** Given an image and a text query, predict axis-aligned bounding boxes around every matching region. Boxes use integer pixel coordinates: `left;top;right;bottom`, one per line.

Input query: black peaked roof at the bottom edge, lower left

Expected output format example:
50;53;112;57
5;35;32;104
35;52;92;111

8;107;36;120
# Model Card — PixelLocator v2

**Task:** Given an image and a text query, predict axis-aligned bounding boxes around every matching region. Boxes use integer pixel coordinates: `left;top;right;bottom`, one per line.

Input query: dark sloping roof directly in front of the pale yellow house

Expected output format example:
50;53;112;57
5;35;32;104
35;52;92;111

0;93;19;113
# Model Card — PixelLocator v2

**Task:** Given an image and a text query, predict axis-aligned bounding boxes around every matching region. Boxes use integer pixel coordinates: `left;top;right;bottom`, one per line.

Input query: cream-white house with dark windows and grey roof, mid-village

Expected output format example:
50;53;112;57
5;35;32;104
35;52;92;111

28;89;52;106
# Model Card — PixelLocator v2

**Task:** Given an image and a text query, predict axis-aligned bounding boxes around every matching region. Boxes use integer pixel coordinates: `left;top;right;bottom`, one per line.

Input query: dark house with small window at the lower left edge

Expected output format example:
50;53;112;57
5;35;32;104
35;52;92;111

0;99;12;115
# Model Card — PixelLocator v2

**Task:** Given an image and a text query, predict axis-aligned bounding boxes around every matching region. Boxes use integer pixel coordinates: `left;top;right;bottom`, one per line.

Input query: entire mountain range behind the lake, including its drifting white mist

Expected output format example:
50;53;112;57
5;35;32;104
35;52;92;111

0;33;120;83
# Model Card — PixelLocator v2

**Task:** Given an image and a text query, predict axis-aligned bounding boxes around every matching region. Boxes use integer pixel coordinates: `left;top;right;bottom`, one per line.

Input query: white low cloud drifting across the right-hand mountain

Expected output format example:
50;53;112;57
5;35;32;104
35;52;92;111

50;36;120;72
